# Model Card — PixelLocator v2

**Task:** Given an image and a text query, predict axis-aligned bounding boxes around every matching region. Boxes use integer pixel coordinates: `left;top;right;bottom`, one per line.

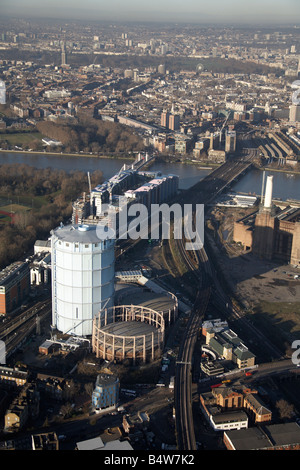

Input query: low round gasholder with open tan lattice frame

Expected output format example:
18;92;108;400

92;305;165;364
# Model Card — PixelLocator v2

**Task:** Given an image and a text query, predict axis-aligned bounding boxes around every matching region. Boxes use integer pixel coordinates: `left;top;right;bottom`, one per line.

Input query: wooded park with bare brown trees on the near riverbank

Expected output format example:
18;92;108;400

0;164;102;269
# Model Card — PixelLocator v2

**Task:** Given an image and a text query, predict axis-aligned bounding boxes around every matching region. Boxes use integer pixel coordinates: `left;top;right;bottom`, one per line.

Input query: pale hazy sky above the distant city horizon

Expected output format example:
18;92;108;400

0;0;300;24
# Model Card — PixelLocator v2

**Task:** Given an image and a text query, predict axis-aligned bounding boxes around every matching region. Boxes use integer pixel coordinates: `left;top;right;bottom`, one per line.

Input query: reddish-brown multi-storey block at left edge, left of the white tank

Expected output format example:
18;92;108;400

0;261;30;315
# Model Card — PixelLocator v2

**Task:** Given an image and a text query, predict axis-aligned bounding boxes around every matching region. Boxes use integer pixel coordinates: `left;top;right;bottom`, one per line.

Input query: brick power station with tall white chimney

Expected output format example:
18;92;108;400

233;176;300;265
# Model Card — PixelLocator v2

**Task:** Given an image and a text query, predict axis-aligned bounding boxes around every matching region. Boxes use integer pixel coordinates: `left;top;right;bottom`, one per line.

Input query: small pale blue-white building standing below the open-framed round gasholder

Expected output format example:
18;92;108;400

92;374;120;411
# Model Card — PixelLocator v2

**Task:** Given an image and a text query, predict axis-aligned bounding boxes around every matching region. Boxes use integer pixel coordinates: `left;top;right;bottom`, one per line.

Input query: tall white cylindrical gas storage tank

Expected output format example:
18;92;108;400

51;225;115;336
